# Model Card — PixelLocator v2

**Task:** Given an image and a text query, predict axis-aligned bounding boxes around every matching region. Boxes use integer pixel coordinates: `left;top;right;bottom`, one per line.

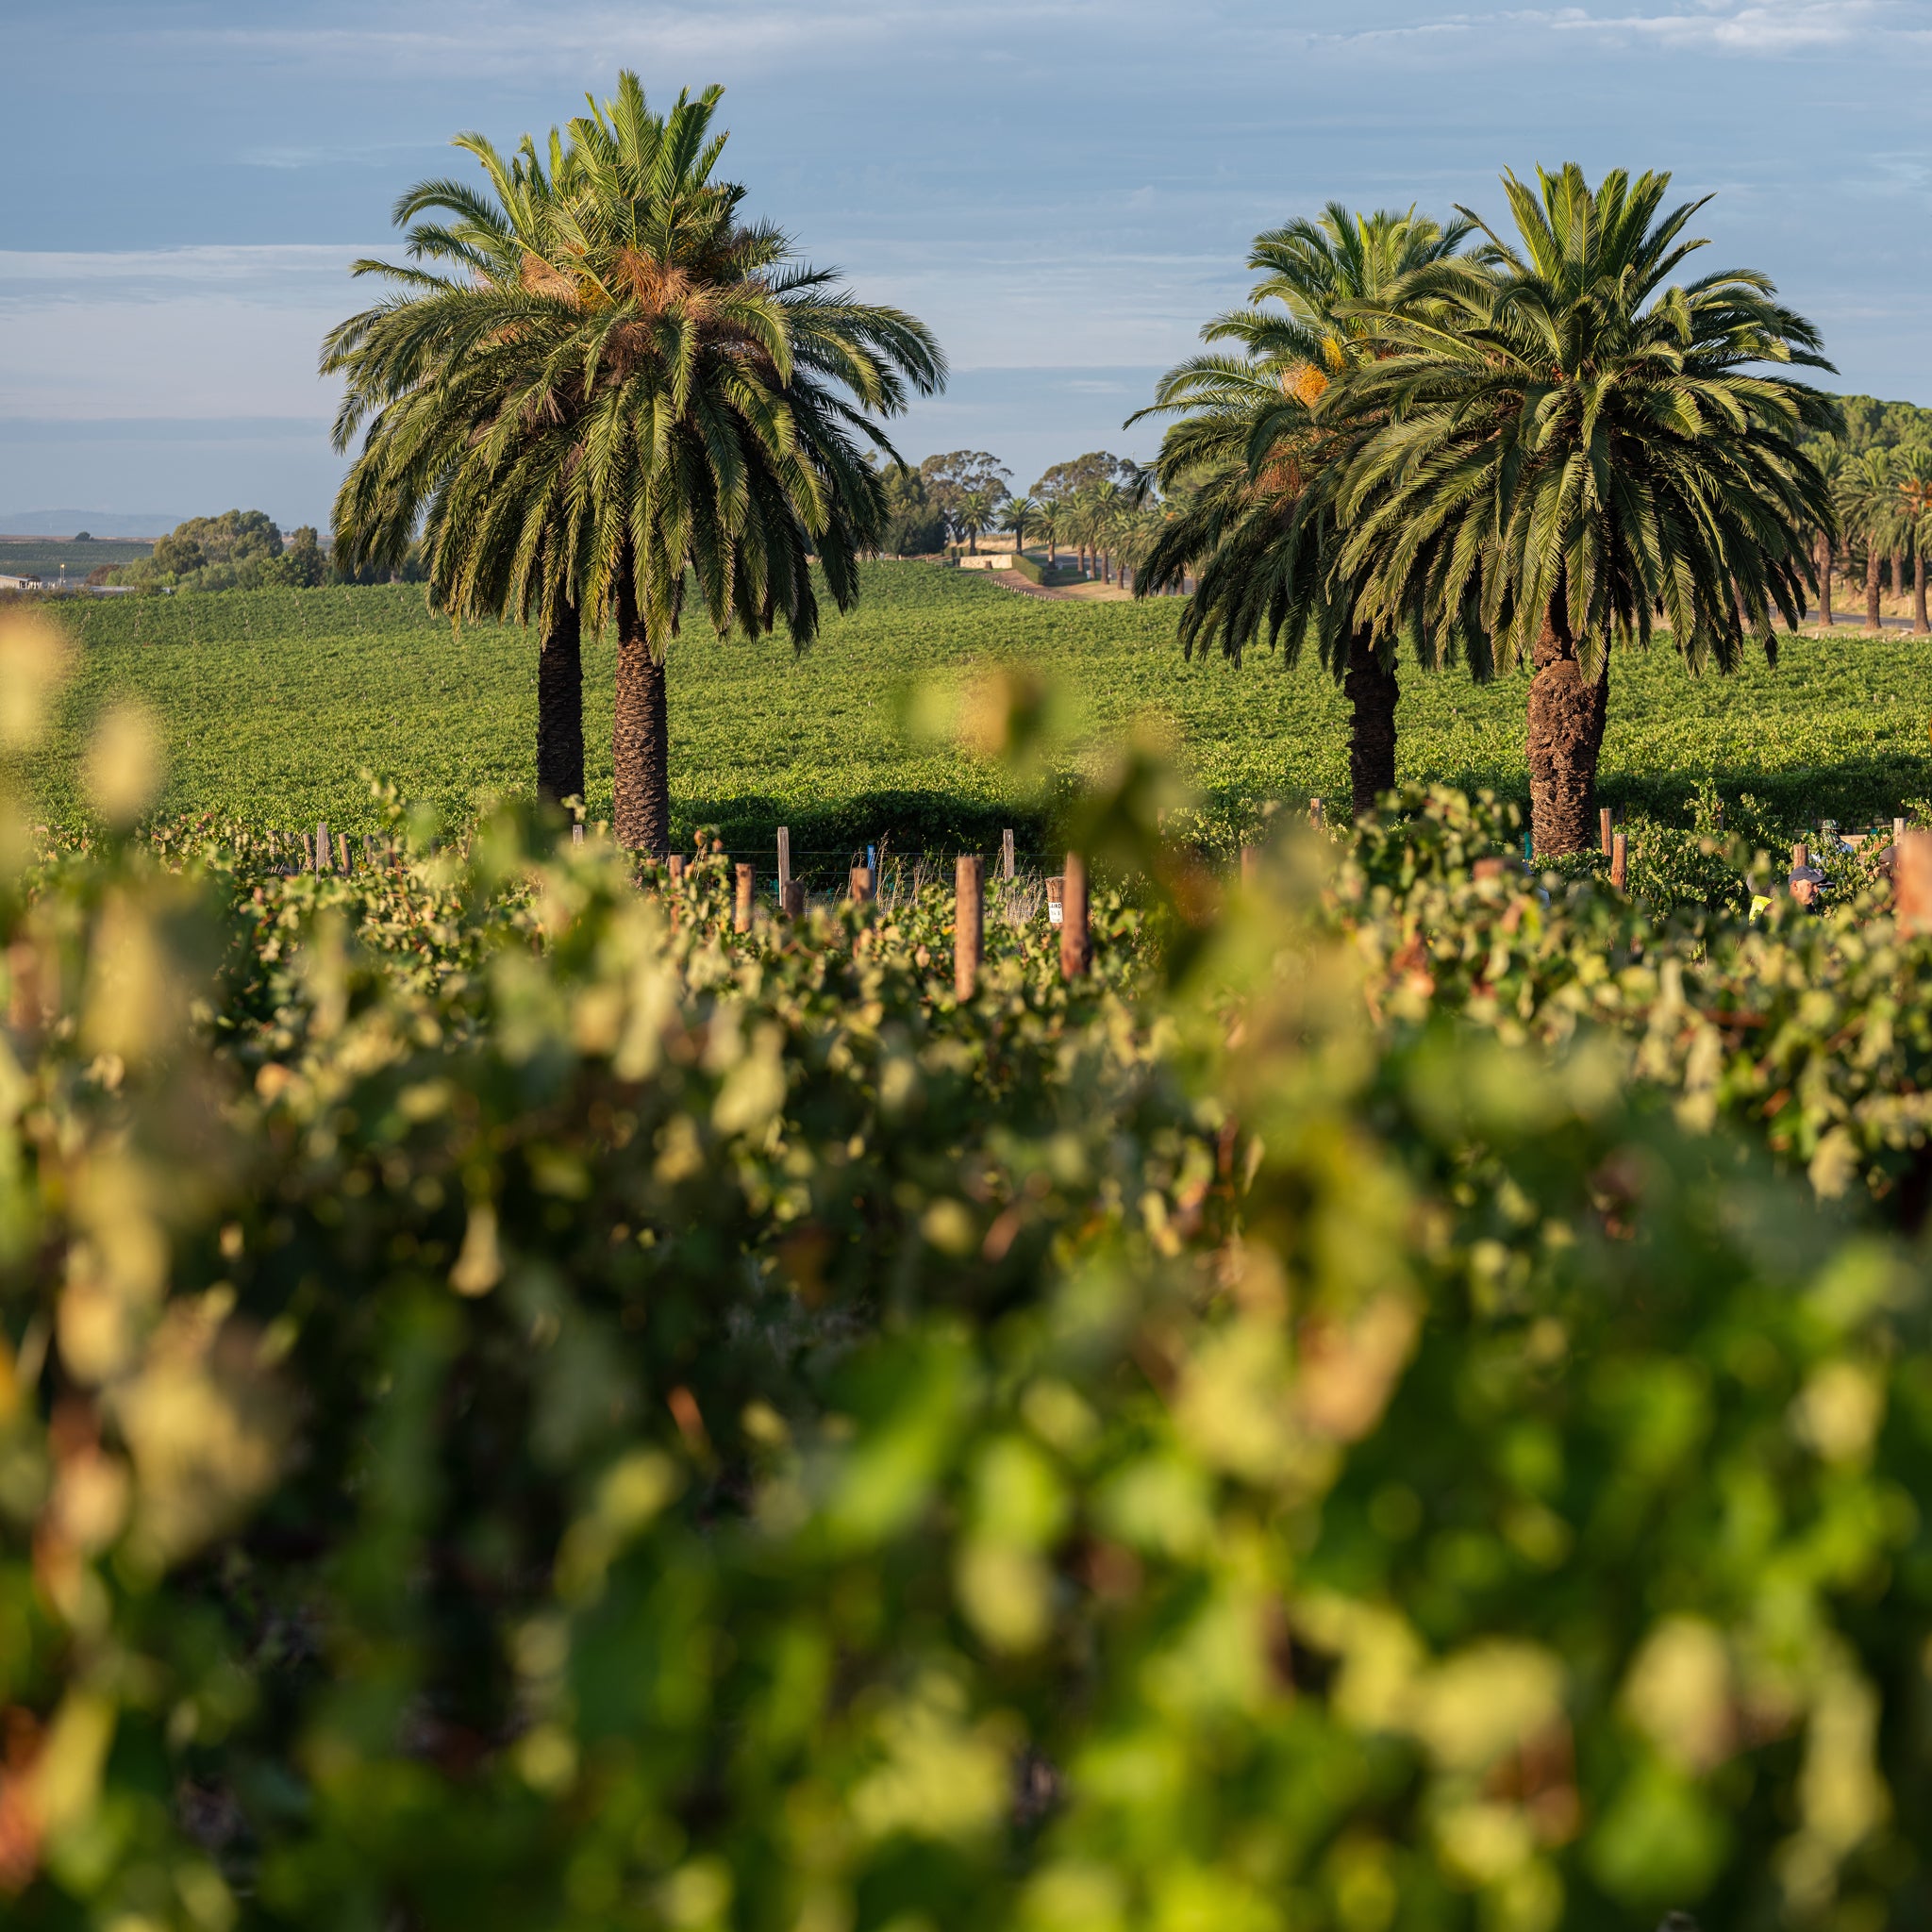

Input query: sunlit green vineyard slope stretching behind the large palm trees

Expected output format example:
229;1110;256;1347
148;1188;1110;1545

33;564;1932;852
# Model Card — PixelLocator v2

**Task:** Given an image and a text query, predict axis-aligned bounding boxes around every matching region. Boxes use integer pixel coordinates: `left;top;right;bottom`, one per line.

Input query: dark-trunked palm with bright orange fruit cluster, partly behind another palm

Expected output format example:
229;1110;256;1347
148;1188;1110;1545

1132;201;1484;817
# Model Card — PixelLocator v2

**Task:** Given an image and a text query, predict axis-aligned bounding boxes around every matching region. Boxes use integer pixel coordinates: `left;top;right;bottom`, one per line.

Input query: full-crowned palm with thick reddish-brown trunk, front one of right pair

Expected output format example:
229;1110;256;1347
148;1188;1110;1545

1333;164;1838;854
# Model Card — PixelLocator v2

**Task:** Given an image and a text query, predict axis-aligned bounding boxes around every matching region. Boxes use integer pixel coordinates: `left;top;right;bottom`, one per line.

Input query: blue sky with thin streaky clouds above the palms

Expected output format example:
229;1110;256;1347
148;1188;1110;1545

0;0;1932;529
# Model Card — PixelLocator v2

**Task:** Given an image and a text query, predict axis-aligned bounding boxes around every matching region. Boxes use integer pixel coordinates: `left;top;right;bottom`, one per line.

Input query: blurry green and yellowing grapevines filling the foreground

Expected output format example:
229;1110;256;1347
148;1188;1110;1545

11;603;1932;1932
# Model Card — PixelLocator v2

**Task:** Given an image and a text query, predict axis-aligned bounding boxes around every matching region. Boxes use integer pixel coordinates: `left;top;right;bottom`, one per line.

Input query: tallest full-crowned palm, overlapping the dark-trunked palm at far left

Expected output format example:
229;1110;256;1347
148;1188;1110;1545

330;72;944;854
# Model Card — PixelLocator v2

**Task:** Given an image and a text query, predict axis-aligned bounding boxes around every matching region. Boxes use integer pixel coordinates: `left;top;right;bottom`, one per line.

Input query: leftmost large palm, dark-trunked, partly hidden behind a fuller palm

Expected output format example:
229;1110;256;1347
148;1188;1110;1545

323;129;583;804
